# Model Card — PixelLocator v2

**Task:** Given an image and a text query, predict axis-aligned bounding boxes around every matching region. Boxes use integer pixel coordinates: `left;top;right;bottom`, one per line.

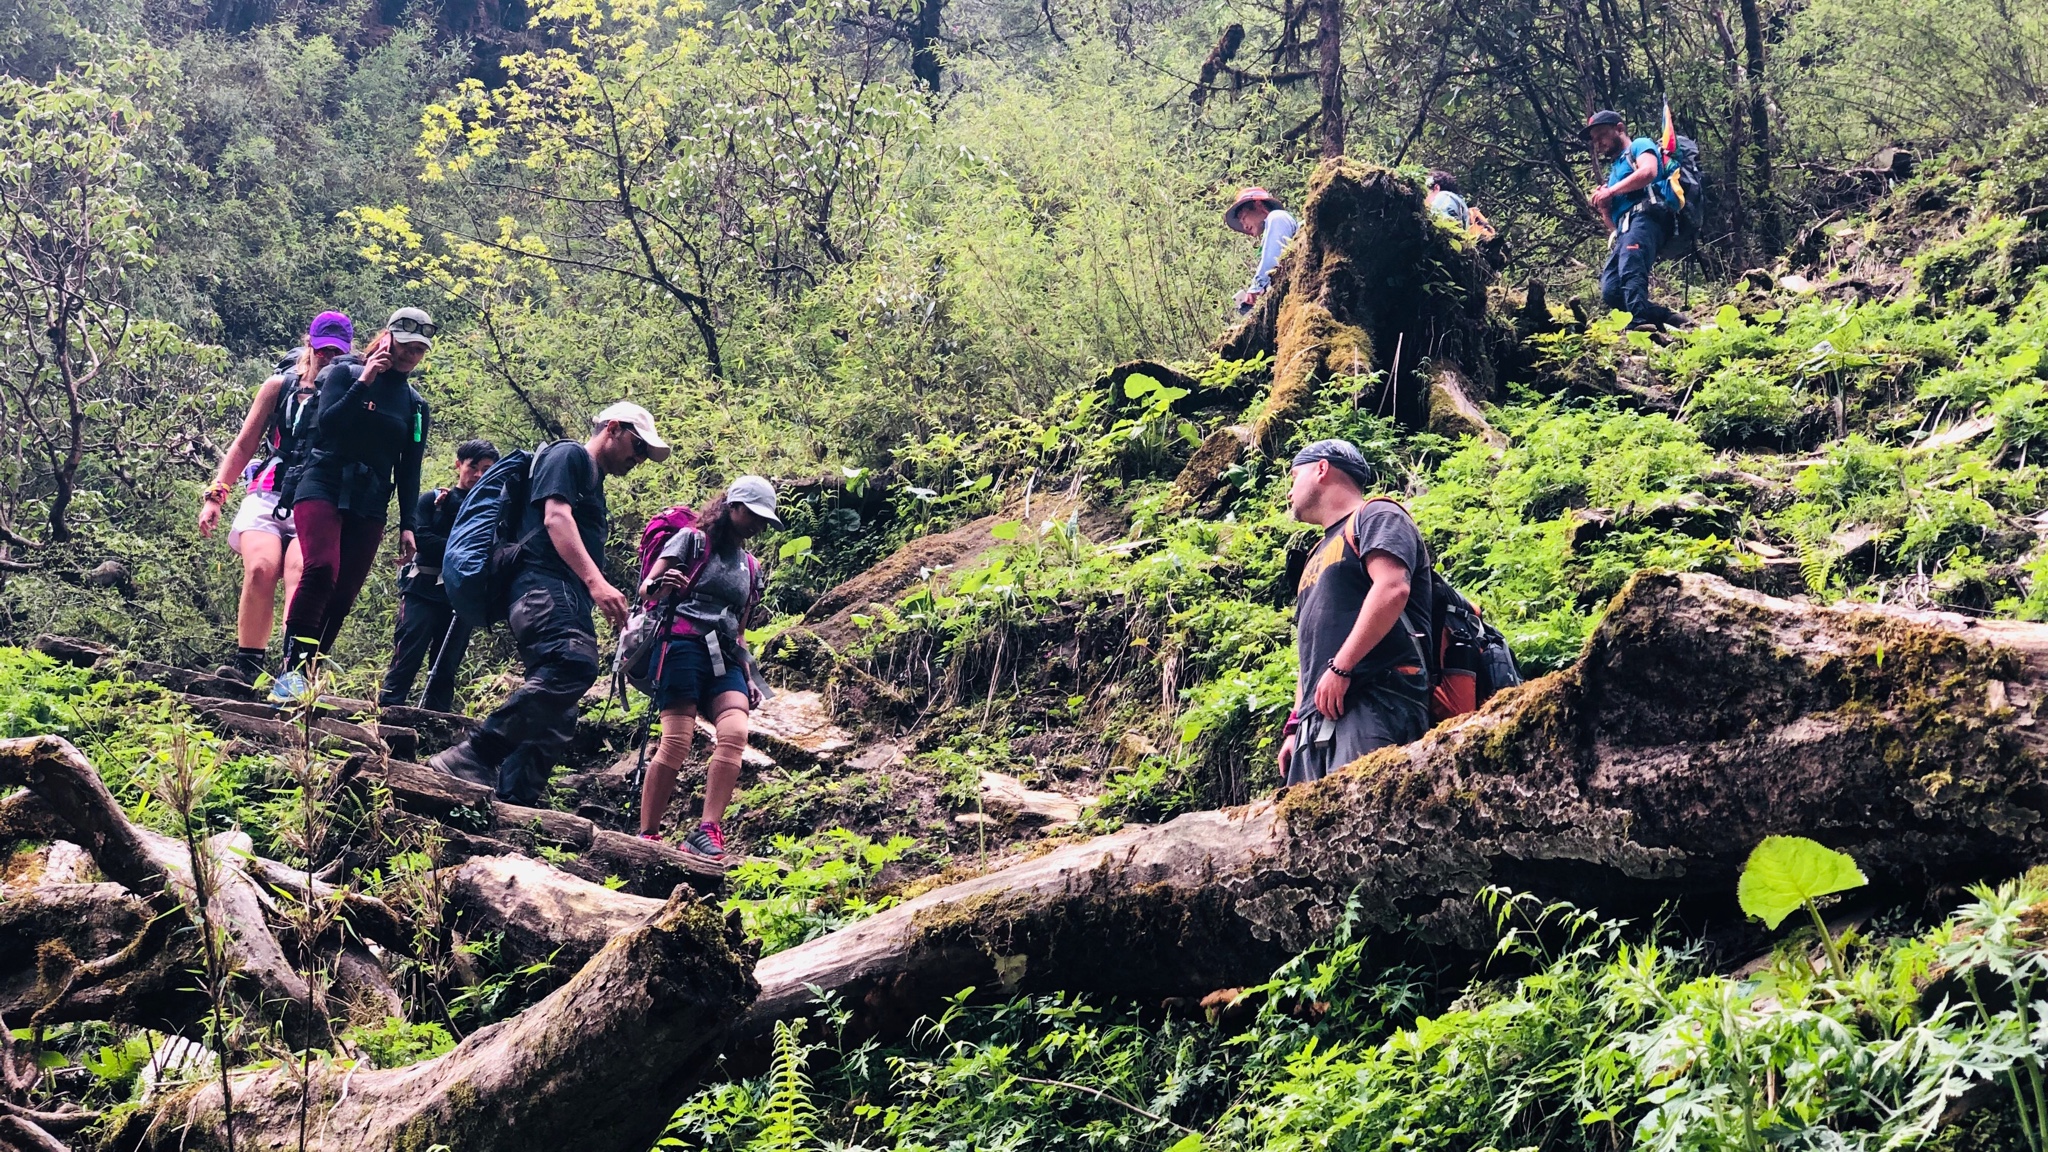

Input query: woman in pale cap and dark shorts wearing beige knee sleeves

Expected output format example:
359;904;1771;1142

641;476;782;859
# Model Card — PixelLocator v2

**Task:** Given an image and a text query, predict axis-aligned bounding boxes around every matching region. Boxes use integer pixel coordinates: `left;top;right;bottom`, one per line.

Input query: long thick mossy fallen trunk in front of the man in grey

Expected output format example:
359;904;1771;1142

743;574;2048;1037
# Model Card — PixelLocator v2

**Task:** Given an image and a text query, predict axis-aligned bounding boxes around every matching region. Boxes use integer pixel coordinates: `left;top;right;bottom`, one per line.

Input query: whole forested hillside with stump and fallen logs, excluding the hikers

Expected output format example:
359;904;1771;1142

0;0;2048;1152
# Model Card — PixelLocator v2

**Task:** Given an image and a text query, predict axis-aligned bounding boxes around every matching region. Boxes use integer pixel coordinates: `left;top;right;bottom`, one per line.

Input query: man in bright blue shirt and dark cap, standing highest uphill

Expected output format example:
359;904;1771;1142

1579;111;1692;328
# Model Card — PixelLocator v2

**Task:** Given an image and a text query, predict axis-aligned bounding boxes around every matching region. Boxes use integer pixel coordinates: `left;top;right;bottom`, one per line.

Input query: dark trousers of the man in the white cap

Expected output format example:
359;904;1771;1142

469;570;600;806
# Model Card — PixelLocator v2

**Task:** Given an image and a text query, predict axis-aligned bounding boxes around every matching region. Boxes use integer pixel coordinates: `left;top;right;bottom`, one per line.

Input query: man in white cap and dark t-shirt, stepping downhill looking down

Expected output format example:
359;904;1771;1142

428;400;670;806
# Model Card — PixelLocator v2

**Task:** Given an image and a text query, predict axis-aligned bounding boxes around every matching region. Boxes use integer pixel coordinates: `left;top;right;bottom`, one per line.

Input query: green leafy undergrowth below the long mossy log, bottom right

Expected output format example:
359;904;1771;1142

659;881;2048;1152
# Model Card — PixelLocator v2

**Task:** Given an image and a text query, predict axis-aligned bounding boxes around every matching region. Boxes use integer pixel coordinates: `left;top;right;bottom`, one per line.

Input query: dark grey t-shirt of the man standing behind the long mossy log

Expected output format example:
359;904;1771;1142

1294;500;1432;699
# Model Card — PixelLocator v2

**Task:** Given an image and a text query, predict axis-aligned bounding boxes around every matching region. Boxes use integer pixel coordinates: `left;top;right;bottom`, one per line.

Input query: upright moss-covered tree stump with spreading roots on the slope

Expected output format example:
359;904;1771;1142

1217;158;1513;453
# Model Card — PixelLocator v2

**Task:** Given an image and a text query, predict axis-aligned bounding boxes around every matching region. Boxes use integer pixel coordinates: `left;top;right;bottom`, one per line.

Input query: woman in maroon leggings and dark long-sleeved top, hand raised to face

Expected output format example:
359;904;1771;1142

270;307;434;703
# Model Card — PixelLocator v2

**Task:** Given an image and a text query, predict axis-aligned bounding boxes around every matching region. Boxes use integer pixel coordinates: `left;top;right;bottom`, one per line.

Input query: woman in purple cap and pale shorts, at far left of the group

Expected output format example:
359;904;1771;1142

199;312;356;685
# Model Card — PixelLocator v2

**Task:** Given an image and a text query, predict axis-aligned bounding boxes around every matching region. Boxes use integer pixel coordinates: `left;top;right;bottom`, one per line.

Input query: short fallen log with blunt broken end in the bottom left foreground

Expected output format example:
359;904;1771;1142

106;894;756;1152
